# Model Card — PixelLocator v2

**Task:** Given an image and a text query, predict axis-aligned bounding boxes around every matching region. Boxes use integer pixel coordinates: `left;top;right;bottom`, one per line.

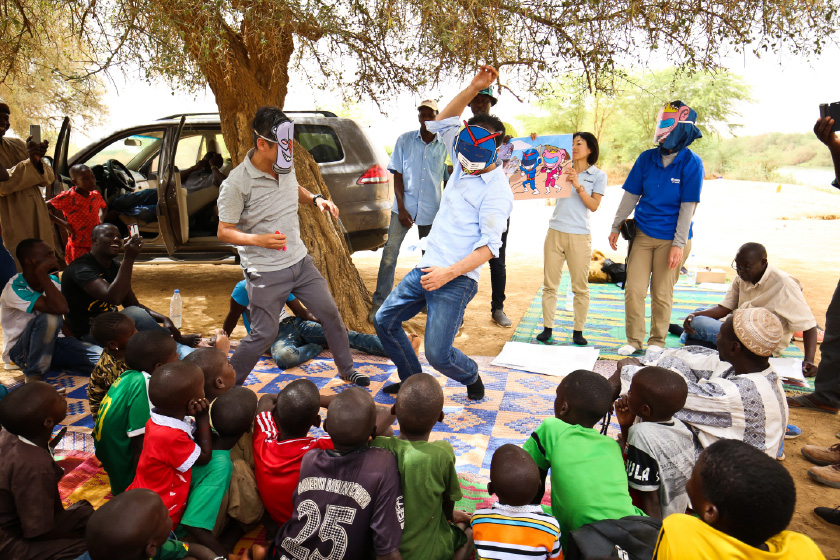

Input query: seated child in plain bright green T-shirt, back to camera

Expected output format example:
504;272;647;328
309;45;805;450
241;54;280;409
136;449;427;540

523;369;641;549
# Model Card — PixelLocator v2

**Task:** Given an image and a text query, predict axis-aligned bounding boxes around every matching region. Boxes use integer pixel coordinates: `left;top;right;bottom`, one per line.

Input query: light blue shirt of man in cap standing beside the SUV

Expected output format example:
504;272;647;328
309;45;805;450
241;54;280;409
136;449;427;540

388;130;446;226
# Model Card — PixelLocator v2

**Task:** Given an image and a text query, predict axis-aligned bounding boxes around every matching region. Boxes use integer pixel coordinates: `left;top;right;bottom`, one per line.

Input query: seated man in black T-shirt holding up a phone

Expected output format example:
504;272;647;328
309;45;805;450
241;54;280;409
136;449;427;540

61;224;200;358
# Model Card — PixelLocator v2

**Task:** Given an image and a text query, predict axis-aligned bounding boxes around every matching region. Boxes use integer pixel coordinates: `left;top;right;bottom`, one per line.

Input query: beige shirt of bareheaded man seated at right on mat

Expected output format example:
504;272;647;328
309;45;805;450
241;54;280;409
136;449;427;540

720;264;817;355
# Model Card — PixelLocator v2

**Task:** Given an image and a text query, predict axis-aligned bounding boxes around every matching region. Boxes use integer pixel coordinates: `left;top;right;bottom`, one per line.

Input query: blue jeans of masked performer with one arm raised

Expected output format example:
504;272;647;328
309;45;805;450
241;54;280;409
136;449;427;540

373;268;478;385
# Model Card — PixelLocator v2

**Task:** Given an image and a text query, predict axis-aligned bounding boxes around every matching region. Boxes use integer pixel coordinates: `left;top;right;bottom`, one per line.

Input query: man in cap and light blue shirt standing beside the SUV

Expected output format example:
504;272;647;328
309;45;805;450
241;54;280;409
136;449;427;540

369;99;446;322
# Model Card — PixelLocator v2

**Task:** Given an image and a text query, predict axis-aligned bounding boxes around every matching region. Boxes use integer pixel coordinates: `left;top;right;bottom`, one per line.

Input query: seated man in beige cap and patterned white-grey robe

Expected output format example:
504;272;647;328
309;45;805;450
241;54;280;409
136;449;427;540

611;307;788;457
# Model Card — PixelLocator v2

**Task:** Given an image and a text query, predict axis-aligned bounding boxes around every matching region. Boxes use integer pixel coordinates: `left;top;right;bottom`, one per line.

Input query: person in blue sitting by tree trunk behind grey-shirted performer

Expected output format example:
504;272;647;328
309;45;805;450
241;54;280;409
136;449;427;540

222;280;420;369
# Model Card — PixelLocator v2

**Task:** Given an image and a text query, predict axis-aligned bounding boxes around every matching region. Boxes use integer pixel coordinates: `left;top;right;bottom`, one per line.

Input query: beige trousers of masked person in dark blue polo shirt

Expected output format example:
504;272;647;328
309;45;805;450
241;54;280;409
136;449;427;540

624;230;691;350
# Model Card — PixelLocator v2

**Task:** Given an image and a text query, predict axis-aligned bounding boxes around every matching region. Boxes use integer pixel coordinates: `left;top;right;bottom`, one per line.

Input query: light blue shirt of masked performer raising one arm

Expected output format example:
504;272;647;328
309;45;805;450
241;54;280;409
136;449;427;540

417;117;513;282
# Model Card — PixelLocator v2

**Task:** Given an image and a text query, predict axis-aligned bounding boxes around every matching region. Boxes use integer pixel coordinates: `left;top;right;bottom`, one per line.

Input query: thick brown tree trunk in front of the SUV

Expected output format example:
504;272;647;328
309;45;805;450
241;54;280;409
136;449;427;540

203;65;373;333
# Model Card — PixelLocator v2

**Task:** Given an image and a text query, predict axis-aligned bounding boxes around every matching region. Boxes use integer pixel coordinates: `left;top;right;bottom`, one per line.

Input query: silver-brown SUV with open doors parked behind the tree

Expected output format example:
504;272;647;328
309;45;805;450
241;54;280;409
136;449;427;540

54;111;393;260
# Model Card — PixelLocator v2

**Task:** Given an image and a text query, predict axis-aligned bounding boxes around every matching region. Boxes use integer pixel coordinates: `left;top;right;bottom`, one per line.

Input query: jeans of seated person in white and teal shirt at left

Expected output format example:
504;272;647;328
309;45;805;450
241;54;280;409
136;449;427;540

9;313;102;375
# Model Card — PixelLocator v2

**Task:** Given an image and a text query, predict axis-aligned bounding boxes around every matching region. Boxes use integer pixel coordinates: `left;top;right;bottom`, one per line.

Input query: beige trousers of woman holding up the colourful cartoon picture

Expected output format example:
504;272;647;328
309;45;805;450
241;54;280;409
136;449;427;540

542;228;592;331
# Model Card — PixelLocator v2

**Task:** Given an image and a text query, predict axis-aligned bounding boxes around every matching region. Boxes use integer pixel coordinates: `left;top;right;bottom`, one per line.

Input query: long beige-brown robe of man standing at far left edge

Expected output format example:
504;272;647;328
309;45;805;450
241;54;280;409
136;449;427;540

0;137;55;270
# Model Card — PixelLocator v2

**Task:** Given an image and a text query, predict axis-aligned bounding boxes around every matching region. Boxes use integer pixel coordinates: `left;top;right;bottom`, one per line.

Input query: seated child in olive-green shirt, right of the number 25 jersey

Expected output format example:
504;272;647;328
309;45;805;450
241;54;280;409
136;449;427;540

371;373;472;560
